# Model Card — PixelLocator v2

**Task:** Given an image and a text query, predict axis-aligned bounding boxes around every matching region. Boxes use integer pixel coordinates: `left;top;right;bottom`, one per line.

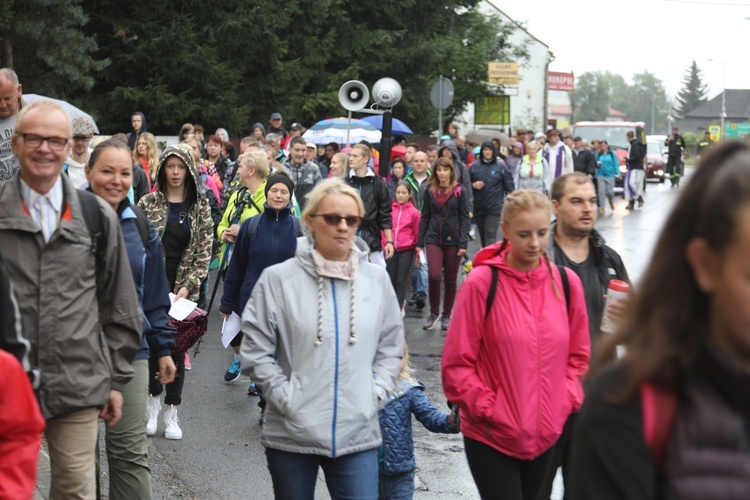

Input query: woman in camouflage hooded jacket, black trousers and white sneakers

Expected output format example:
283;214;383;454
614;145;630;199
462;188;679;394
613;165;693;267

138;144;214;439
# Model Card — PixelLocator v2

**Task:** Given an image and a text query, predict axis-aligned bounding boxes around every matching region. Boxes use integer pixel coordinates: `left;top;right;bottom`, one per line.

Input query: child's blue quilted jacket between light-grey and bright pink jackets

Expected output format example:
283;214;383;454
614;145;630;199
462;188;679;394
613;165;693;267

378;379;458;476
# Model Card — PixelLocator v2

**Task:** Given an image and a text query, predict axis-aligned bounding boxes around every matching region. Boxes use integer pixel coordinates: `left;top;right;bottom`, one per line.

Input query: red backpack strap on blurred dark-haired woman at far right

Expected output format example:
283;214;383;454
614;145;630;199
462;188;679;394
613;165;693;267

641;384;677;467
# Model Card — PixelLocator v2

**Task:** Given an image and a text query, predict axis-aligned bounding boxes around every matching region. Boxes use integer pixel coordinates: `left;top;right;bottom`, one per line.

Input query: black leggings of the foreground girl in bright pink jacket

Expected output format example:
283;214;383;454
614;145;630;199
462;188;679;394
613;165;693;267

464;437;556;500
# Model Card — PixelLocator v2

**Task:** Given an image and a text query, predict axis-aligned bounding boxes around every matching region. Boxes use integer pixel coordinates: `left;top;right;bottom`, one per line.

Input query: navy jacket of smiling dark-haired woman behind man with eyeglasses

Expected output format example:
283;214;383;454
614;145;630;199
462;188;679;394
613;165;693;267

117;198;176;360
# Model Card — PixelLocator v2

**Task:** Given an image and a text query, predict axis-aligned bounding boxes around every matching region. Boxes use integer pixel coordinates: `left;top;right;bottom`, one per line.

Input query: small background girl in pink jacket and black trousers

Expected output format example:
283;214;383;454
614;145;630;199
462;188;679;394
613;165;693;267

383;181;421;313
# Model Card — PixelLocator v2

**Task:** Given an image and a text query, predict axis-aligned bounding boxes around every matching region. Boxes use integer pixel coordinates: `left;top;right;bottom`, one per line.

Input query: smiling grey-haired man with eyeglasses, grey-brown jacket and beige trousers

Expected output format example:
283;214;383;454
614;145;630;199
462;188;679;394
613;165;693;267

0;101;143;499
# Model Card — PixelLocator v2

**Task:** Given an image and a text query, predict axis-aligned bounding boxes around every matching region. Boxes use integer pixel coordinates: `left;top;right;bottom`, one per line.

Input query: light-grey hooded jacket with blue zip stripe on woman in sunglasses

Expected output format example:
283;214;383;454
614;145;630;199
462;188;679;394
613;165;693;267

241;236;404;458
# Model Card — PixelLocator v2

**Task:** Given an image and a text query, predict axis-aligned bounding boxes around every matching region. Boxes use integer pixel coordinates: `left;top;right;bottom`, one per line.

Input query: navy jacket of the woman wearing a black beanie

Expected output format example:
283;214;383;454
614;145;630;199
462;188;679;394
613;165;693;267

219;203;300;316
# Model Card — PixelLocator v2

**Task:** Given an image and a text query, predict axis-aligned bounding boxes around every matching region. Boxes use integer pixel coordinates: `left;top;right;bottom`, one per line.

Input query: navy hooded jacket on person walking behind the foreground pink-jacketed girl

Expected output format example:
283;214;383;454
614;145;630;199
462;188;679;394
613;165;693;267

469;141;515;215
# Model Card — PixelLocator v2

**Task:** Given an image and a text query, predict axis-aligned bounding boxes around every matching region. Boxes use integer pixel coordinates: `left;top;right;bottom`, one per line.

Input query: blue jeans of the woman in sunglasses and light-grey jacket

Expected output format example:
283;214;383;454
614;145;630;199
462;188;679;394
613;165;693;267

266;448;378;500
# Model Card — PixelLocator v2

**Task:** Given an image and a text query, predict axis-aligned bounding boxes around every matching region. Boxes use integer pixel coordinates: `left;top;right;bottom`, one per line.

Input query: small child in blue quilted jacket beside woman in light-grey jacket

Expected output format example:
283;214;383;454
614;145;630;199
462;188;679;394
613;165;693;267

378;343;458;500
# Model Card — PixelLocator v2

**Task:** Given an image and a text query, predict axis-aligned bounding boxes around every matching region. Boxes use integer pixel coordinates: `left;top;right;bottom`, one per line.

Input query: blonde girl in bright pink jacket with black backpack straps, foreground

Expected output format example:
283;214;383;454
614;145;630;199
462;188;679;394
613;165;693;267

442;190;590;500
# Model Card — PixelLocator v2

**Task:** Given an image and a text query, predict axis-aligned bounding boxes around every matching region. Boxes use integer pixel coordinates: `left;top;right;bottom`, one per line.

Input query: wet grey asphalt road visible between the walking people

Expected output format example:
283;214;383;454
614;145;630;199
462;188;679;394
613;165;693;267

36;174;679;499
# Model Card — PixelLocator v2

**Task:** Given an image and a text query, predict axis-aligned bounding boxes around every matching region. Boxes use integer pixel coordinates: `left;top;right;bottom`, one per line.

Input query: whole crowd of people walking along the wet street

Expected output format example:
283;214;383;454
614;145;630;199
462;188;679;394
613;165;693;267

0;62;750;500
